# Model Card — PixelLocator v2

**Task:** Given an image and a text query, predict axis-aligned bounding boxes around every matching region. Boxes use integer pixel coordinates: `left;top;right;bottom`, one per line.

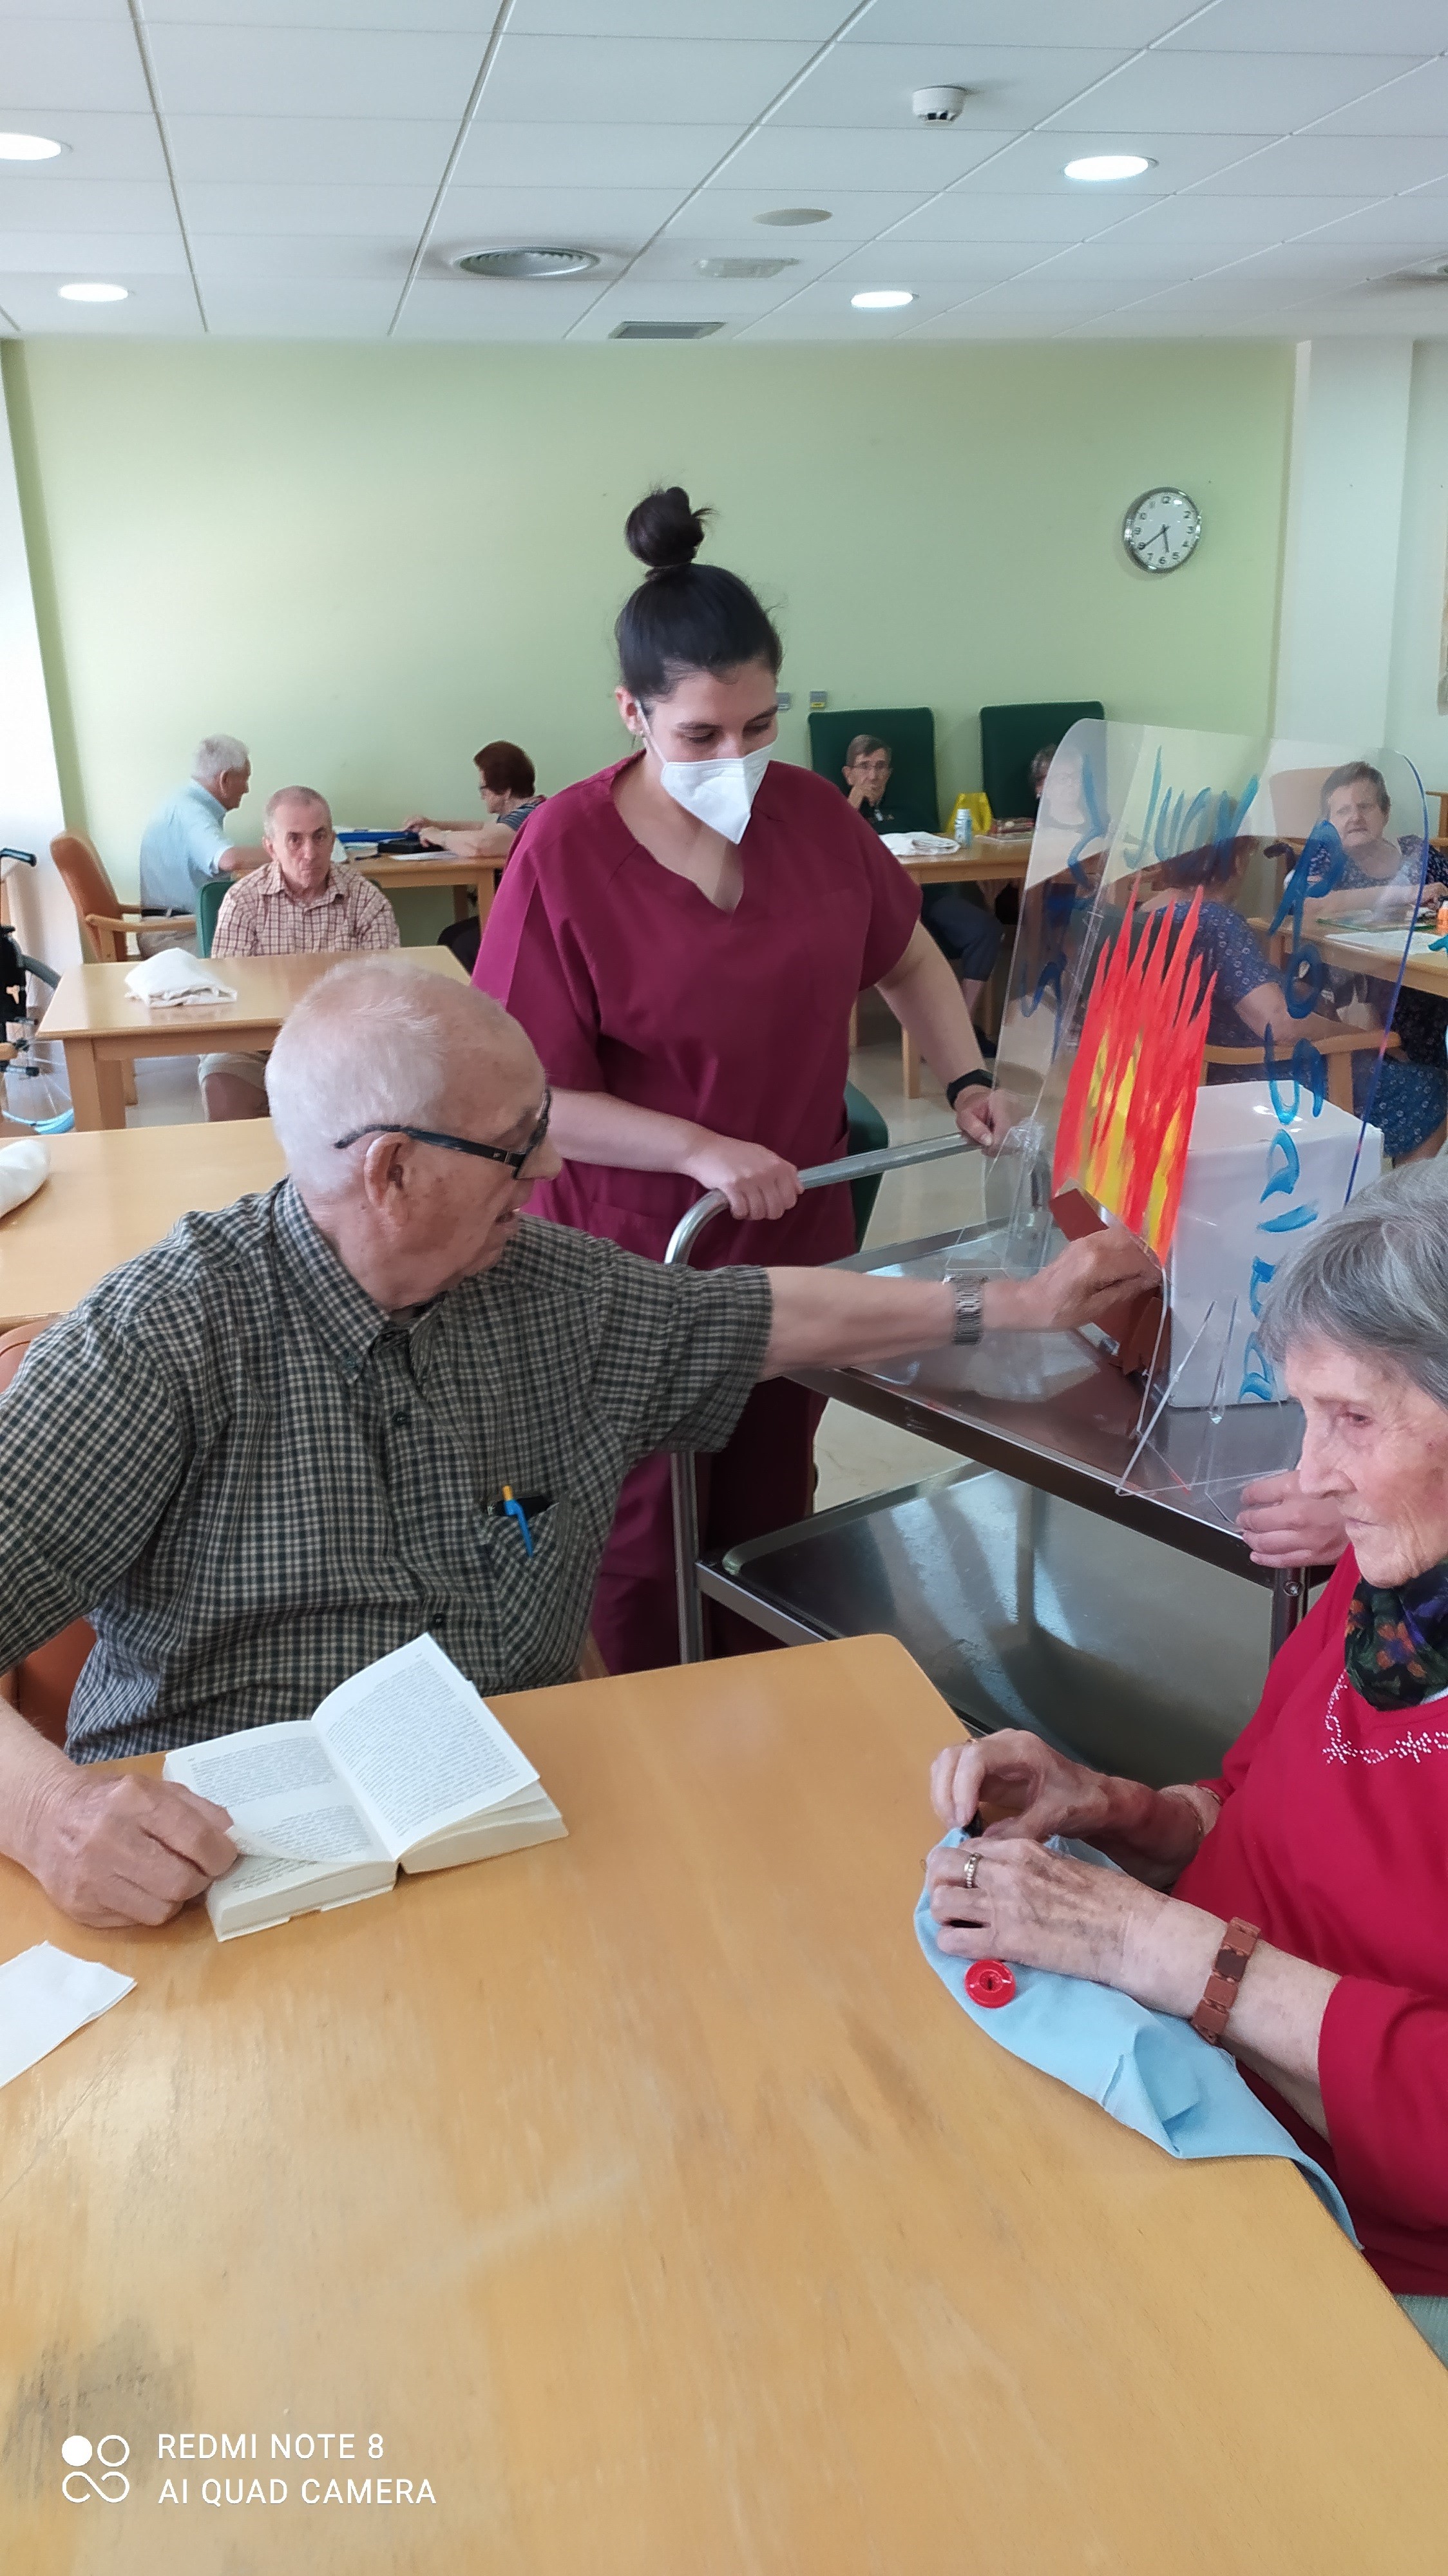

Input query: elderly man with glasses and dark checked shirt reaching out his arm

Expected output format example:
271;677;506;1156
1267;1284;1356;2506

0;961;1147;1924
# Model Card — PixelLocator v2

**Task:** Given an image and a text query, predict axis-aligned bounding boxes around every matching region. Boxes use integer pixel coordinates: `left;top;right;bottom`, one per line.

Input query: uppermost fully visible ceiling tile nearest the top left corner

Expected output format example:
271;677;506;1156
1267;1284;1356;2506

152;26;482;121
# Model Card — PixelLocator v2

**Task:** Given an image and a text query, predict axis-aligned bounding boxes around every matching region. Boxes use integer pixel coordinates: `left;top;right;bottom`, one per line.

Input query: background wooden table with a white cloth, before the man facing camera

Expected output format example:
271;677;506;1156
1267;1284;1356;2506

41;945;466;1128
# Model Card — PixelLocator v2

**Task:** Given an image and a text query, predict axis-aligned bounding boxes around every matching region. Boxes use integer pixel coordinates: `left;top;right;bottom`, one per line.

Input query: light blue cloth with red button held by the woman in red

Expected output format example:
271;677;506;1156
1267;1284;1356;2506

915;1834;1358;2244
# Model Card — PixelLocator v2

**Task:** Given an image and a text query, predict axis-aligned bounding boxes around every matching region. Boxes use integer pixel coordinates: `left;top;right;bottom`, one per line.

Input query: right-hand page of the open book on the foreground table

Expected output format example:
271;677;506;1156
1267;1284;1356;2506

312;1636;538;1860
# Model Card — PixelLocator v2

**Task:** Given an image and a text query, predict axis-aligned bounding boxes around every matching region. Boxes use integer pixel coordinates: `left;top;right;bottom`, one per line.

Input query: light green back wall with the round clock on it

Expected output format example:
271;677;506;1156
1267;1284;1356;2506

5;340;1291;907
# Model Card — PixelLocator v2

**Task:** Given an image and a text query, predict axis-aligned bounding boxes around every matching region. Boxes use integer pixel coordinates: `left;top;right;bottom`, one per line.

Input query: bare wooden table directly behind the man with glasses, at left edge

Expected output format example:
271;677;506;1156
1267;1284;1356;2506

0;1118;286;1332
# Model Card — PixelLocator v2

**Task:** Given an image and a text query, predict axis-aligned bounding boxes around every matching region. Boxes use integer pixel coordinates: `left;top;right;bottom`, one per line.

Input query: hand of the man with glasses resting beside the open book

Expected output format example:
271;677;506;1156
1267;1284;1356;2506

18;1765;237;1932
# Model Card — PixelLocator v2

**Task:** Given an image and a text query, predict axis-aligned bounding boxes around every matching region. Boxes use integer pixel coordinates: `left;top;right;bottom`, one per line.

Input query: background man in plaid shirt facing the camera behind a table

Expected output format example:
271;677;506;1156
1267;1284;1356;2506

201;788;397;1118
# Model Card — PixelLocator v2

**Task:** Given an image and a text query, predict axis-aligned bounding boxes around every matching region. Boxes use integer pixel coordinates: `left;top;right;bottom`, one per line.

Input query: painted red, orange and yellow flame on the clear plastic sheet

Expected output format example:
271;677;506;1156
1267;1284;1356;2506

1051;889;1216;1260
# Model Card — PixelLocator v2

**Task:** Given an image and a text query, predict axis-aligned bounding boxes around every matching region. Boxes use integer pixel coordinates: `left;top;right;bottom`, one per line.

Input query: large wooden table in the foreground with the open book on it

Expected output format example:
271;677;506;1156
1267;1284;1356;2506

0;1638;1448;2576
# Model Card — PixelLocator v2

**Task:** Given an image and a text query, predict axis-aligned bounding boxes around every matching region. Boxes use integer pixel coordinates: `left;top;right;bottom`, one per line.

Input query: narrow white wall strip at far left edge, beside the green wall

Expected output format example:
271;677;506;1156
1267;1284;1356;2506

0;361;80;966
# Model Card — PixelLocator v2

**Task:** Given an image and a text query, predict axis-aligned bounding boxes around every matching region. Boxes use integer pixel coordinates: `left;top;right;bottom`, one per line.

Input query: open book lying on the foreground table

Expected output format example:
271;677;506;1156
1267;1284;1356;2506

162;1636;567;1940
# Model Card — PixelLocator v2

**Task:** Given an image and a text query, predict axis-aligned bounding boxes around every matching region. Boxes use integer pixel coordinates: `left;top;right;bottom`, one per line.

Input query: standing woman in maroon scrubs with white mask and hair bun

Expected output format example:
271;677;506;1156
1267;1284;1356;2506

474;487;995;1672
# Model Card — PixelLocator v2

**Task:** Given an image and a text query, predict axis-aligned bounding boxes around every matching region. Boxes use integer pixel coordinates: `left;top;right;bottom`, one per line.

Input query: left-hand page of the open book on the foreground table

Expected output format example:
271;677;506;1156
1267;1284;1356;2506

165;1718;392;1888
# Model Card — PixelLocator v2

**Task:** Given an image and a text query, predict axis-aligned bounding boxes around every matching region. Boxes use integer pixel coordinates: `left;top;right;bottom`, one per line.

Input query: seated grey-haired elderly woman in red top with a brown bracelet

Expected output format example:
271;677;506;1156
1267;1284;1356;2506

930;1164;1448;2360
